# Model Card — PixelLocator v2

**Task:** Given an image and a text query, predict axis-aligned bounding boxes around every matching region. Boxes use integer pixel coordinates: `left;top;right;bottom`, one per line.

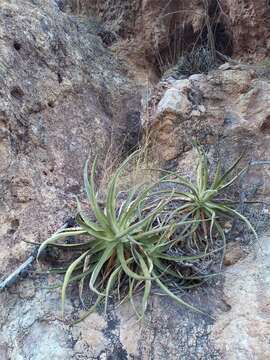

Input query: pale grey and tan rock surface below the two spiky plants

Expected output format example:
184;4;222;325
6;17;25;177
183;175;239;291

0;236;270;360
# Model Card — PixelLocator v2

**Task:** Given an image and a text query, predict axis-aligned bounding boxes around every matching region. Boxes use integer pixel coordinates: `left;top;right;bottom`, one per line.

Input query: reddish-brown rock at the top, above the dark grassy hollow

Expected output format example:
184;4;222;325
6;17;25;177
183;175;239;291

66;0;270;73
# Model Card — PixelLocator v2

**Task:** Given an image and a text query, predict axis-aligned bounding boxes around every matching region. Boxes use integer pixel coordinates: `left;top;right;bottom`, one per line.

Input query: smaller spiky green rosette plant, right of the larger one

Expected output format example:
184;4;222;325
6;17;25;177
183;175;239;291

159;145;257;253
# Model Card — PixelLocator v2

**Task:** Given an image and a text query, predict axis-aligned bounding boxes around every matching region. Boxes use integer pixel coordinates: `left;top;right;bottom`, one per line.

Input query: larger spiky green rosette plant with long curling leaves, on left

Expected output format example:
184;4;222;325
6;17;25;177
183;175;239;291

38;152;209;316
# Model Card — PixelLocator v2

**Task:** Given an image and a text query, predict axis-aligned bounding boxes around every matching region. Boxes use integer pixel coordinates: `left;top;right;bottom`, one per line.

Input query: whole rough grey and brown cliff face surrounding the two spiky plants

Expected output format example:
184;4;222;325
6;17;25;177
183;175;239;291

0;0;270;360
